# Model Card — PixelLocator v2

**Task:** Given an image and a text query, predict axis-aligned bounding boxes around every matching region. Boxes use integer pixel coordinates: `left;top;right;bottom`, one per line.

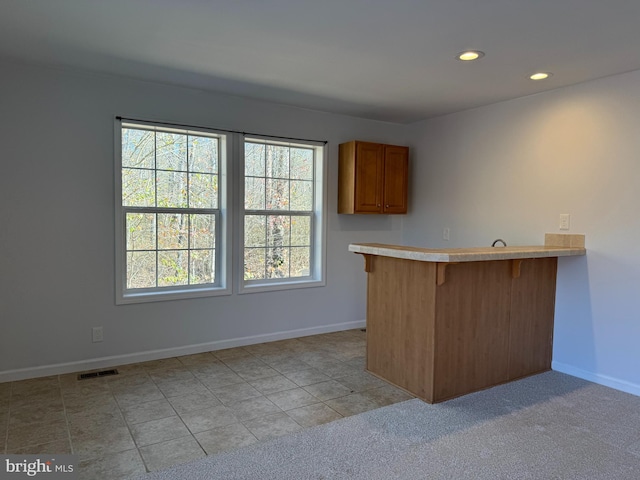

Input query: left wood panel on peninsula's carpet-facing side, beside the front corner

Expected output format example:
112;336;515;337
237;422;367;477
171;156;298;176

433;260;512;402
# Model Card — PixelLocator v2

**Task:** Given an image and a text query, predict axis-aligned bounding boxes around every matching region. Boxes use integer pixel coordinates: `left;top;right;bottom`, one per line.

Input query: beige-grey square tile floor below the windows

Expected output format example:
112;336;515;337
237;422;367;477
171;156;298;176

0;330;411;480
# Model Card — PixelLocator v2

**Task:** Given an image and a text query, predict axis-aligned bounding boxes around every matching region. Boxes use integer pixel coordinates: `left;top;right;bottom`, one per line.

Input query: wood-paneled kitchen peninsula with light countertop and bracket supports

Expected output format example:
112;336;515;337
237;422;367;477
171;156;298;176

349;234;586;403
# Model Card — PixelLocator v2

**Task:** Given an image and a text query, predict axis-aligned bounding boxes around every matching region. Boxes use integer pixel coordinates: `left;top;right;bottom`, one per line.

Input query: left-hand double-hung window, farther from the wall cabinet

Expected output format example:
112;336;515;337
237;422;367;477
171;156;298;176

116;122;226;303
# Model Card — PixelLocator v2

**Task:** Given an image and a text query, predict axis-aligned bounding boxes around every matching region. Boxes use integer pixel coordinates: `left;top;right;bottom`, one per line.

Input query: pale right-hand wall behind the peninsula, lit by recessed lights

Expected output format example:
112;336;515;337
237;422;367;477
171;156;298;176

403;71;640;395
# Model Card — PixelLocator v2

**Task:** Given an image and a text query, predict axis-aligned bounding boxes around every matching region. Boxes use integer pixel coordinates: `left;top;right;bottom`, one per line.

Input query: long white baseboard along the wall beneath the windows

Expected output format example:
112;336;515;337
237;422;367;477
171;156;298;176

0;320;366;383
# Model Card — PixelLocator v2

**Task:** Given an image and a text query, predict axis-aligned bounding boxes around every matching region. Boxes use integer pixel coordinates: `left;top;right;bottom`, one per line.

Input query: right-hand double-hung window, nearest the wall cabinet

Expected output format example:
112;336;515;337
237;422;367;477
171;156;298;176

242;137;324;291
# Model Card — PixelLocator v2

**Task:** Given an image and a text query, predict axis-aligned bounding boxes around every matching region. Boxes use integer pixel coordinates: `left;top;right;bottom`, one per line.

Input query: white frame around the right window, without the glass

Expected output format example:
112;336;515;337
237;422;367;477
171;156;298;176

236;134;327;294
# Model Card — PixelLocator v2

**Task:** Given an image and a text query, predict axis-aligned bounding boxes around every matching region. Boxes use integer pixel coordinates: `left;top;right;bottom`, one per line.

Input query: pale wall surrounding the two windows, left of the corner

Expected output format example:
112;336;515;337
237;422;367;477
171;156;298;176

0;63;407;381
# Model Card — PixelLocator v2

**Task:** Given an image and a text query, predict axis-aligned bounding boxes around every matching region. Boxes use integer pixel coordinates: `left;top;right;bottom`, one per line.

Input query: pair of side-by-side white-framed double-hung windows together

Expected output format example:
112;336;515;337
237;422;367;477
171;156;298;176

115;119;326;304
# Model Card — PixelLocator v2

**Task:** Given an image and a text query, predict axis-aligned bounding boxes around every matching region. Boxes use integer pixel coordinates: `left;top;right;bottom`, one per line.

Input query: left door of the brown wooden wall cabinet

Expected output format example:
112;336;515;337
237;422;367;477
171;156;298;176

355;142;384;213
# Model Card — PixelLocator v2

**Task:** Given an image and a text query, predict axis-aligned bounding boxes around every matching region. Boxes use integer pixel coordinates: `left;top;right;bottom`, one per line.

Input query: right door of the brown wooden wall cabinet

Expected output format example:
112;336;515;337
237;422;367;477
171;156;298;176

383;145;409;213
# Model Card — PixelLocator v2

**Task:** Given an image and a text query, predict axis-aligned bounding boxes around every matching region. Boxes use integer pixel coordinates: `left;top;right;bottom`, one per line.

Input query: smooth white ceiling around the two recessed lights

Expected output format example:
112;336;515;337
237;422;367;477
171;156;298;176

0;0;640;123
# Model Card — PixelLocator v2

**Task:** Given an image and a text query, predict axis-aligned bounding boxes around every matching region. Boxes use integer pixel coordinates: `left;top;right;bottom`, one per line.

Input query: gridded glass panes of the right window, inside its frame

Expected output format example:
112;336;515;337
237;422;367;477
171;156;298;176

244;141;315;281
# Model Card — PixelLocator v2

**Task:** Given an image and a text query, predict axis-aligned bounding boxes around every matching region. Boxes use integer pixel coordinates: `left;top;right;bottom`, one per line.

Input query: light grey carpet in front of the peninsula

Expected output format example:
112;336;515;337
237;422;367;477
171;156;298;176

131;372;640;480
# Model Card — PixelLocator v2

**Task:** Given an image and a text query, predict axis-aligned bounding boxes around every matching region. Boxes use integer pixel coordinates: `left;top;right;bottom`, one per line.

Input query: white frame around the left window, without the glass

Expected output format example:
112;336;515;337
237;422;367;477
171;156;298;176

114;118;234;305
